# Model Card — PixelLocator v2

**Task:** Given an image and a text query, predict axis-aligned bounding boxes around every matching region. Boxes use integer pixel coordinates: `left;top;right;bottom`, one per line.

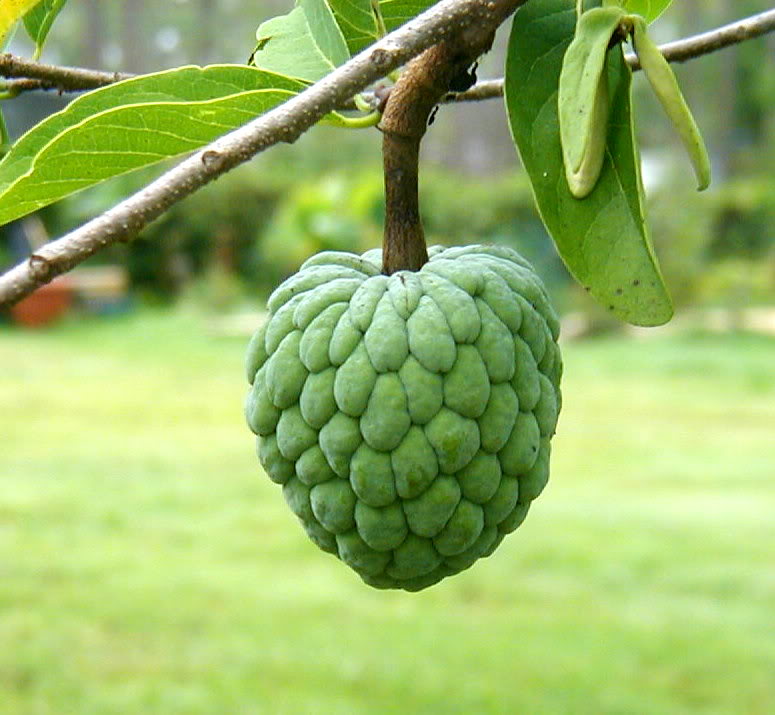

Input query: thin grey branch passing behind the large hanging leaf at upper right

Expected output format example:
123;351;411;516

445;10;775;102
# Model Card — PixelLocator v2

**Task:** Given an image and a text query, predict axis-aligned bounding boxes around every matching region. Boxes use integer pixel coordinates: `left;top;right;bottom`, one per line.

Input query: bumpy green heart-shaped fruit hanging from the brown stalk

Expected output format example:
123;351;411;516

246;246;562;591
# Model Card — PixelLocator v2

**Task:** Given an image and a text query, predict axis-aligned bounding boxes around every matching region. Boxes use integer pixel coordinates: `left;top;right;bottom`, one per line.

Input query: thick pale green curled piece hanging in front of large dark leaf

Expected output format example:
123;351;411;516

558;7;625;198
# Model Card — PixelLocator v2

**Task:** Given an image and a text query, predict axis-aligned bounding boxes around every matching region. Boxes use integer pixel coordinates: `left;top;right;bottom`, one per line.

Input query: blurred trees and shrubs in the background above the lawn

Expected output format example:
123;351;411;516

0;0;775;323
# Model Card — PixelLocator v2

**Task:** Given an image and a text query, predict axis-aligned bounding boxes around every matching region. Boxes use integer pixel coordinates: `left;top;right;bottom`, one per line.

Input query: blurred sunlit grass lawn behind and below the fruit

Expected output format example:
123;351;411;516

0;313;775;715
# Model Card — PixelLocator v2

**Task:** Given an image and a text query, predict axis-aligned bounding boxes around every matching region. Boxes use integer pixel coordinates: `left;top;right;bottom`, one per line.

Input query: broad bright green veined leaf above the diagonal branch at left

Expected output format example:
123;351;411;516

0;65;318;224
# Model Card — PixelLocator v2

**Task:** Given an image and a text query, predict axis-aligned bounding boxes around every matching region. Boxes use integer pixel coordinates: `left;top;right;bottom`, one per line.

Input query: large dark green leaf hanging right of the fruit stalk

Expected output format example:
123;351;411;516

505;0;672;325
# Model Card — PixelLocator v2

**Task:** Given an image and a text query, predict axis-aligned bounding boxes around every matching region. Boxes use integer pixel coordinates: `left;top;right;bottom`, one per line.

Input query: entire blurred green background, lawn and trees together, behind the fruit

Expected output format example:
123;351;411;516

0;0;775;715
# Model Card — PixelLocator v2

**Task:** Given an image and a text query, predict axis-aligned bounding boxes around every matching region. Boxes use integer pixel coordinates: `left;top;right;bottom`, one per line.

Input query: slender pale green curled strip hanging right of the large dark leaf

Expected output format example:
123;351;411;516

629;16;710;191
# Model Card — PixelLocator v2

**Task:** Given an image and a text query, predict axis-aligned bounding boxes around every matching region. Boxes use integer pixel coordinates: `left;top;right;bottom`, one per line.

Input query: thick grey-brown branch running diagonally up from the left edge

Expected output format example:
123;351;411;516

0;0;521;307
